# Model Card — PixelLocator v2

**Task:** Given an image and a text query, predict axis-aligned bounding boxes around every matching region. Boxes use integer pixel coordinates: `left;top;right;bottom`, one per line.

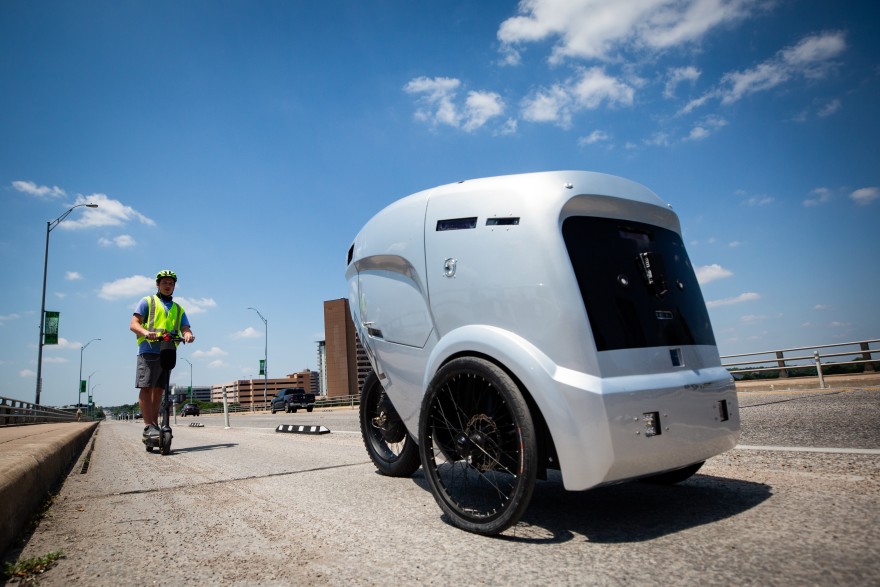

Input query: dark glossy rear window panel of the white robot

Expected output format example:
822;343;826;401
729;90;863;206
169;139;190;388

562;216;715;351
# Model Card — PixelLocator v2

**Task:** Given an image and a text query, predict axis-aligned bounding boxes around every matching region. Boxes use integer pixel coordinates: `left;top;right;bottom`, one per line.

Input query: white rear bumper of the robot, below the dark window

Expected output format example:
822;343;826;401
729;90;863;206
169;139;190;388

543;367;740;490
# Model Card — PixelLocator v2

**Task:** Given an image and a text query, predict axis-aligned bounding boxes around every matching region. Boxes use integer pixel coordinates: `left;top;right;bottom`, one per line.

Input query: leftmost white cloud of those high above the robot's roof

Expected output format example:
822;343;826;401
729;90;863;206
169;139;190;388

403;77;510;132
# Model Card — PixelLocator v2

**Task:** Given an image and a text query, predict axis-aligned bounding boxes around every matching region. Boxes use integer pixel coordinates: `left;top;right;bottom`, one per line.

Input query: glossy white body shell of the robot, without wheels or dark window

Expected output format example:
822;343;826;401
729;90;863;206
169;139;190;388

346;171;739;489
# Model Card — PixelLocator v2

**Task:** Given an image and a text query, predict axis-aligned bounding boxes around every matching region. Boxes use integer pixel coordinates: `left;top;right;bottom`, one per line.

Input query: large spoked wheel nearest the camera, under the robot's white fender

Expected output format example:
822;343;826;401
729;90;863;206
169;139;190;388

419;357;537;535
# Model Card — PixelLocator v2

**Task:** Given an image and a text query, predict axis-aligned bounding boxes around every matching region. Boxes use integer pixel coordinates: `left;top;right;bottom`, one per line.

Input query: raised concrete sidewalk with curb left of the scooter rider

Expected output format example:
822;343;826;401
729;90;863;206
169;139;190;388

0;422;98;554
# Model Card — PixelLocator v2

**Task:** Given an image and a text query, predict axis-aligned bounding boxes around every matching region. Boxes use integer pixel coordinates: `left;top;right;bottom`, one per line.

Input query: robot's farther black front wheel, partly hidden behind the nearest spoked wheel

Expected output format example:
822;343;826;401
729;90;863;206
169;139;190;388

358;372;419;477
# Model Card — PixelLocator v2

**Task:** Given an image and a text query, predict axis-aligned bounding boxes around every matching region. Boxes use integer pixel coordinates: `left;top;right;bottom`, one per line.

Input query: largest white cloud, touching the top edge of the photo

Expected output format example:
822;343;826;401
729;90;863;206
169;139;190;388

497;0;756;65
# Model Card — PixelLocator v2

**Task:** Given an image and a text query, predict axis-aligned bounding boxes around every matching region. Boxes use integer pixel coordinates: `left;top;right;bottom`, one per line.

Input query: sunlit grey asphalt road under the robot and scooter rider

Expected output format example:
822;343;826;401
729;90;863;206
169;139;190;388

8;389;880;586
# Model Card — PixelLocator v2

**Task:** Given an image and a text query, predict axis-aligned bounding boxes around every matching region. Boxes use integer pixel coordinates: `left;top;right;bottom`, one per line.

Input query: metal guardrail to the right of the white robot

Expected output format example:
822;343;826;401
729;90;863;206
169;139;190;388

721;339;880;389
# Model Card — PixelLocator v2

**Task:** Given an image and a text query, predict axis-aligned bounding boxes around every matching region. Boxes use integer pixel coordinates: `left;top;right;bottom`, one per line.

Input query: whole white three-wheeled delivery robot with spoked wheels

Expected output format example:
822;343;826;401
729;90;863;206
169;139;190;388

346;171;740;535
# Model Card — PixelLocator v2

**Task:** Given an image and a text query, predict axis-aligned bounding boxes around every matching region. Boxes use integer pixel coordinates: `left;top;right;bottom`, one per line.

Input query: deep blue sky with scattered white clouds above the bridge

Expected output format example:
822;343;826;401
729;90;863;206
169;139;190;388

0;0;880;405
